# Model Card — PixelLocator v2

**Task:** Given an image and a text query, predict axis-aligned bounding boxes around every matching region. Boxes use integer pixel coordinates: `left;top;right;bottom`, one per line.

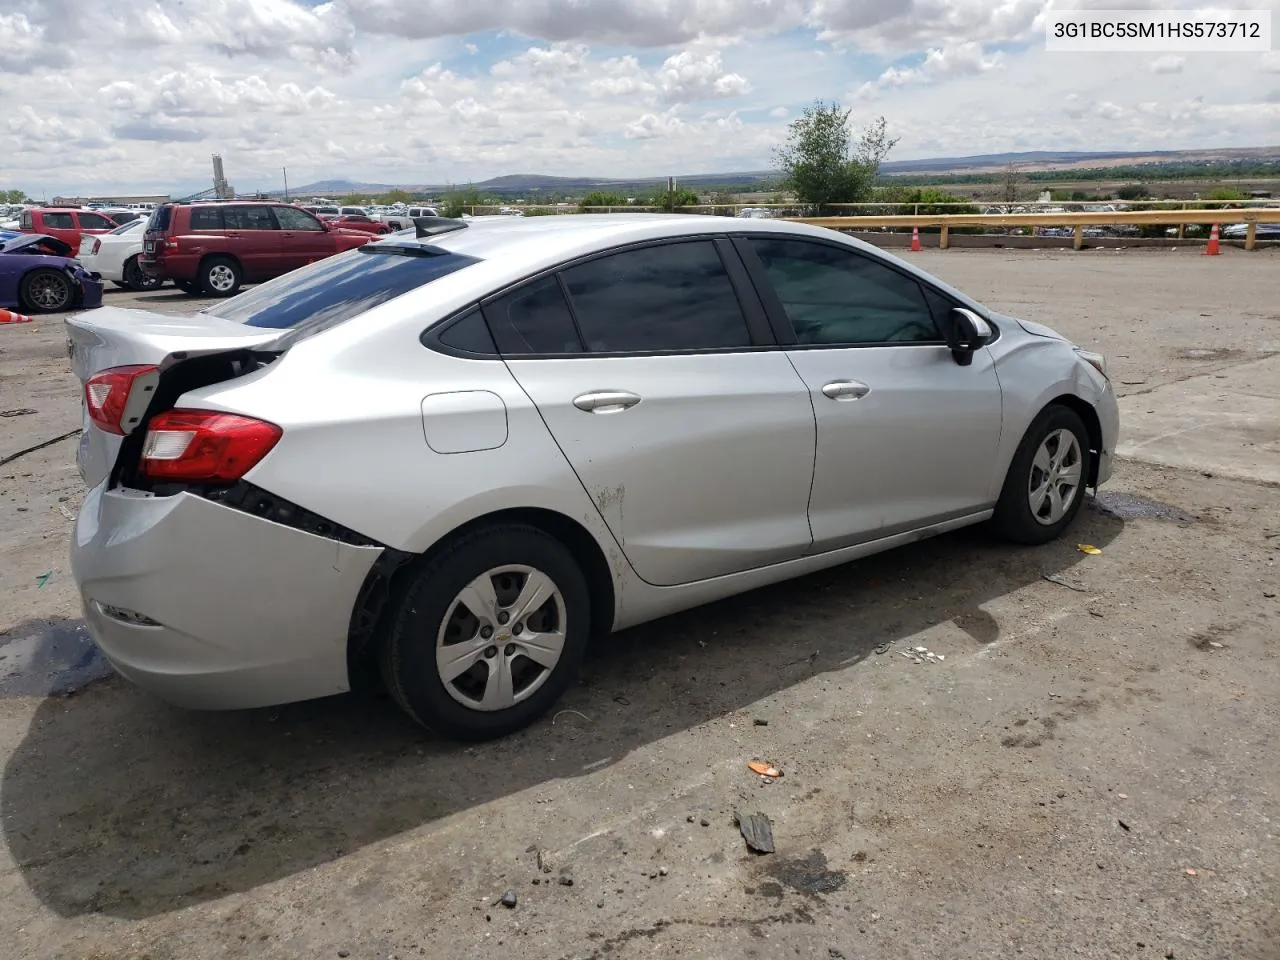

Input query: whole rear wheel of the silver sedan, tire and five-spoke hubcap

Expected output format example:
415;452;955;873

381;525;591;740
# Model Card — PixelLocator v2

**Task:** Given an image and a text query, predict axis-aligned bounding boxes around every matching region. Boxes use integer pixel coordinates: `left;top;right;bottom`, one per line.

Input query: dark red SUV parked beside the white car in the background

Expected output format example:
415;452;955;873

138;201;370;297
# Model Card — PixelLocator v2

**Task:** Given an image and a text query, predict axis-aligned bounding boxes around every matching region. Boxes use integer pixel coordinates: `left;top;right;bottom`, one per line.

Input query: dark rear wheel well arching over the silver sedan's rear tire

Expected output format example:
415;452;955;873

347;507;614;684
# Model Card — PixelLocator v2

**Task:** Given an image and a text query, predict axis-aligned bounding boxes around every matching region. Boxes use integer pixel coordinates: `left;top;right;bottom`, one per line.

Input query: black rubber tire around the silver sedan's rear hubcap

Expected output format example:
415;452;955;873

380;524;591;740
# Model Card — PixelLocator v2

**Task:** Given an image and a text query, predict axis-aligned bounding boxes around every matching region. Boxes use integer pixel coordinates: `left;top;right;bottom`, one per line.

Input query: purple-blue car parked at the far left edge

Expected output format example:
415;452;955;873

0;230;102;314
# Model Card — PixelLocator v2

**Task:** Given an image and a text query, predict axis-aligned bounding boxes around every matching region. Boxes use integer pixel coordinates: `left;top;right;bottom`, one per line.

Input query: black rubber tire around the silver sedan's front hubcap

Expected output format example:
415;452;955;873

992;404;1093;544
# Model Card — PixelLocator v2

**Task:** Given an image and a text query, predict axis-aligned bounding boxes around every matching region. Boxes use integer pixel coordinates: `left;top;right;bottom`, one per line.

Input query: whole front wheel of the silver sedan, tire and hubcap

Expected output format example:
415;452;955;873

992;404;1093;544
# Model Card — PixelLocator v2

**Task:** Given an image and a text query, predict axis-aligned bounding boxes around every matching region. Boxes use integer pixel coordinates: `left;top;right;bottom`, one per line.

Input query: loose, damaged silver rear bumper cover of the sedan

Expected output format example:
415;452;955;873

72;484;383;709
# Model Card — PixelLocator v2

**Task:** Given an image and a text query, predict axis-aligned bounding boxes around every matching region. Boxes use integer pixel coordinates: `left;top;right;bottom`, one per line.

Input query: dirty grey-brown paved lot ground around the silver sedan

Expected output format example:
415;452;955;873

0;251;1280;960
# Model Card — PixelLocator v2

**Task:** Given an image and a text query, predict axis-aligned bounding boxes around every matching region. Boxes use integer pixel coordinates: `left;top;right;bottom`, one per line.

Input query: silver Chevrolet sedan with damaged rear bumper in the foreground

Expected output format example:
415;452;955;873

67;214;1119;739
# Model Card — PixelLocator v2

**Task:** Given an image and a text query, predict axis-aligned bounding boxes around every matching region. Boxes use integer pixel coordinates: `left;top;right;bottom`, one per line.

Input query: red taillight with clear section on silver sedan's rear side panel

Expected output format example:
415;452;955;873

142;410;283;484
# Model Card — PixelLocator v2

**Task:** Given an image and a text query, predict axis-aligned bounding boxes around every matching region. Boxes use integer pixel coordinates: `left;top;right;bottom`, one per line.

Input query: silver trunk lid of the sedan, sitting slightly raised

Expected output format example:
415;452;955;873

65;307;282;488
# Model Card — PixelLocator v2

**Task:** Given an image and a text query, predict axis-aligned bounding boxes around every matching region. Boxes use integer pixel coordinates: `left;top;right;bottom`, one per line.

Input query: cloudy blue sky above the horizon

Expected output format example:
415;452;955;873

0;0;1280;197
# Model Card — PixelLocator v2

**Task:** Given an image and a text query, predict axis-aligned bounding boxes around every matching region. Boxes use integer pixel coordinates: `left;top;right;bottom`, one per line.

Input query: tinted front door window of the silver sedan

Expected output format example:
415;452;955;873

751;238;941;343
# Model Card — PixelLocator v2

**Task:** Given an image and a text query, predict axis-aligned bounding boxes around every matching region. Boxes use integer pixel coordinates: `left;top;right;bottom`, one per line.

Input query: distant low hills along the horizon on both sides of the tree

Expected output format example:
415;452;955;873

275;146;1280;197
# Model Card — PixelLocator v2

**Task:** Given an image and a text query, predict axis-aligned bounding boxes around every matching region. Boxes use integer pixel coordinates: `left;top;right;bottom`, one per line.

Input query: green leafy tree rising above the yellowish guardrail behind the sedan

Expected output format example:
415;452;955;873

774;100;897;209
